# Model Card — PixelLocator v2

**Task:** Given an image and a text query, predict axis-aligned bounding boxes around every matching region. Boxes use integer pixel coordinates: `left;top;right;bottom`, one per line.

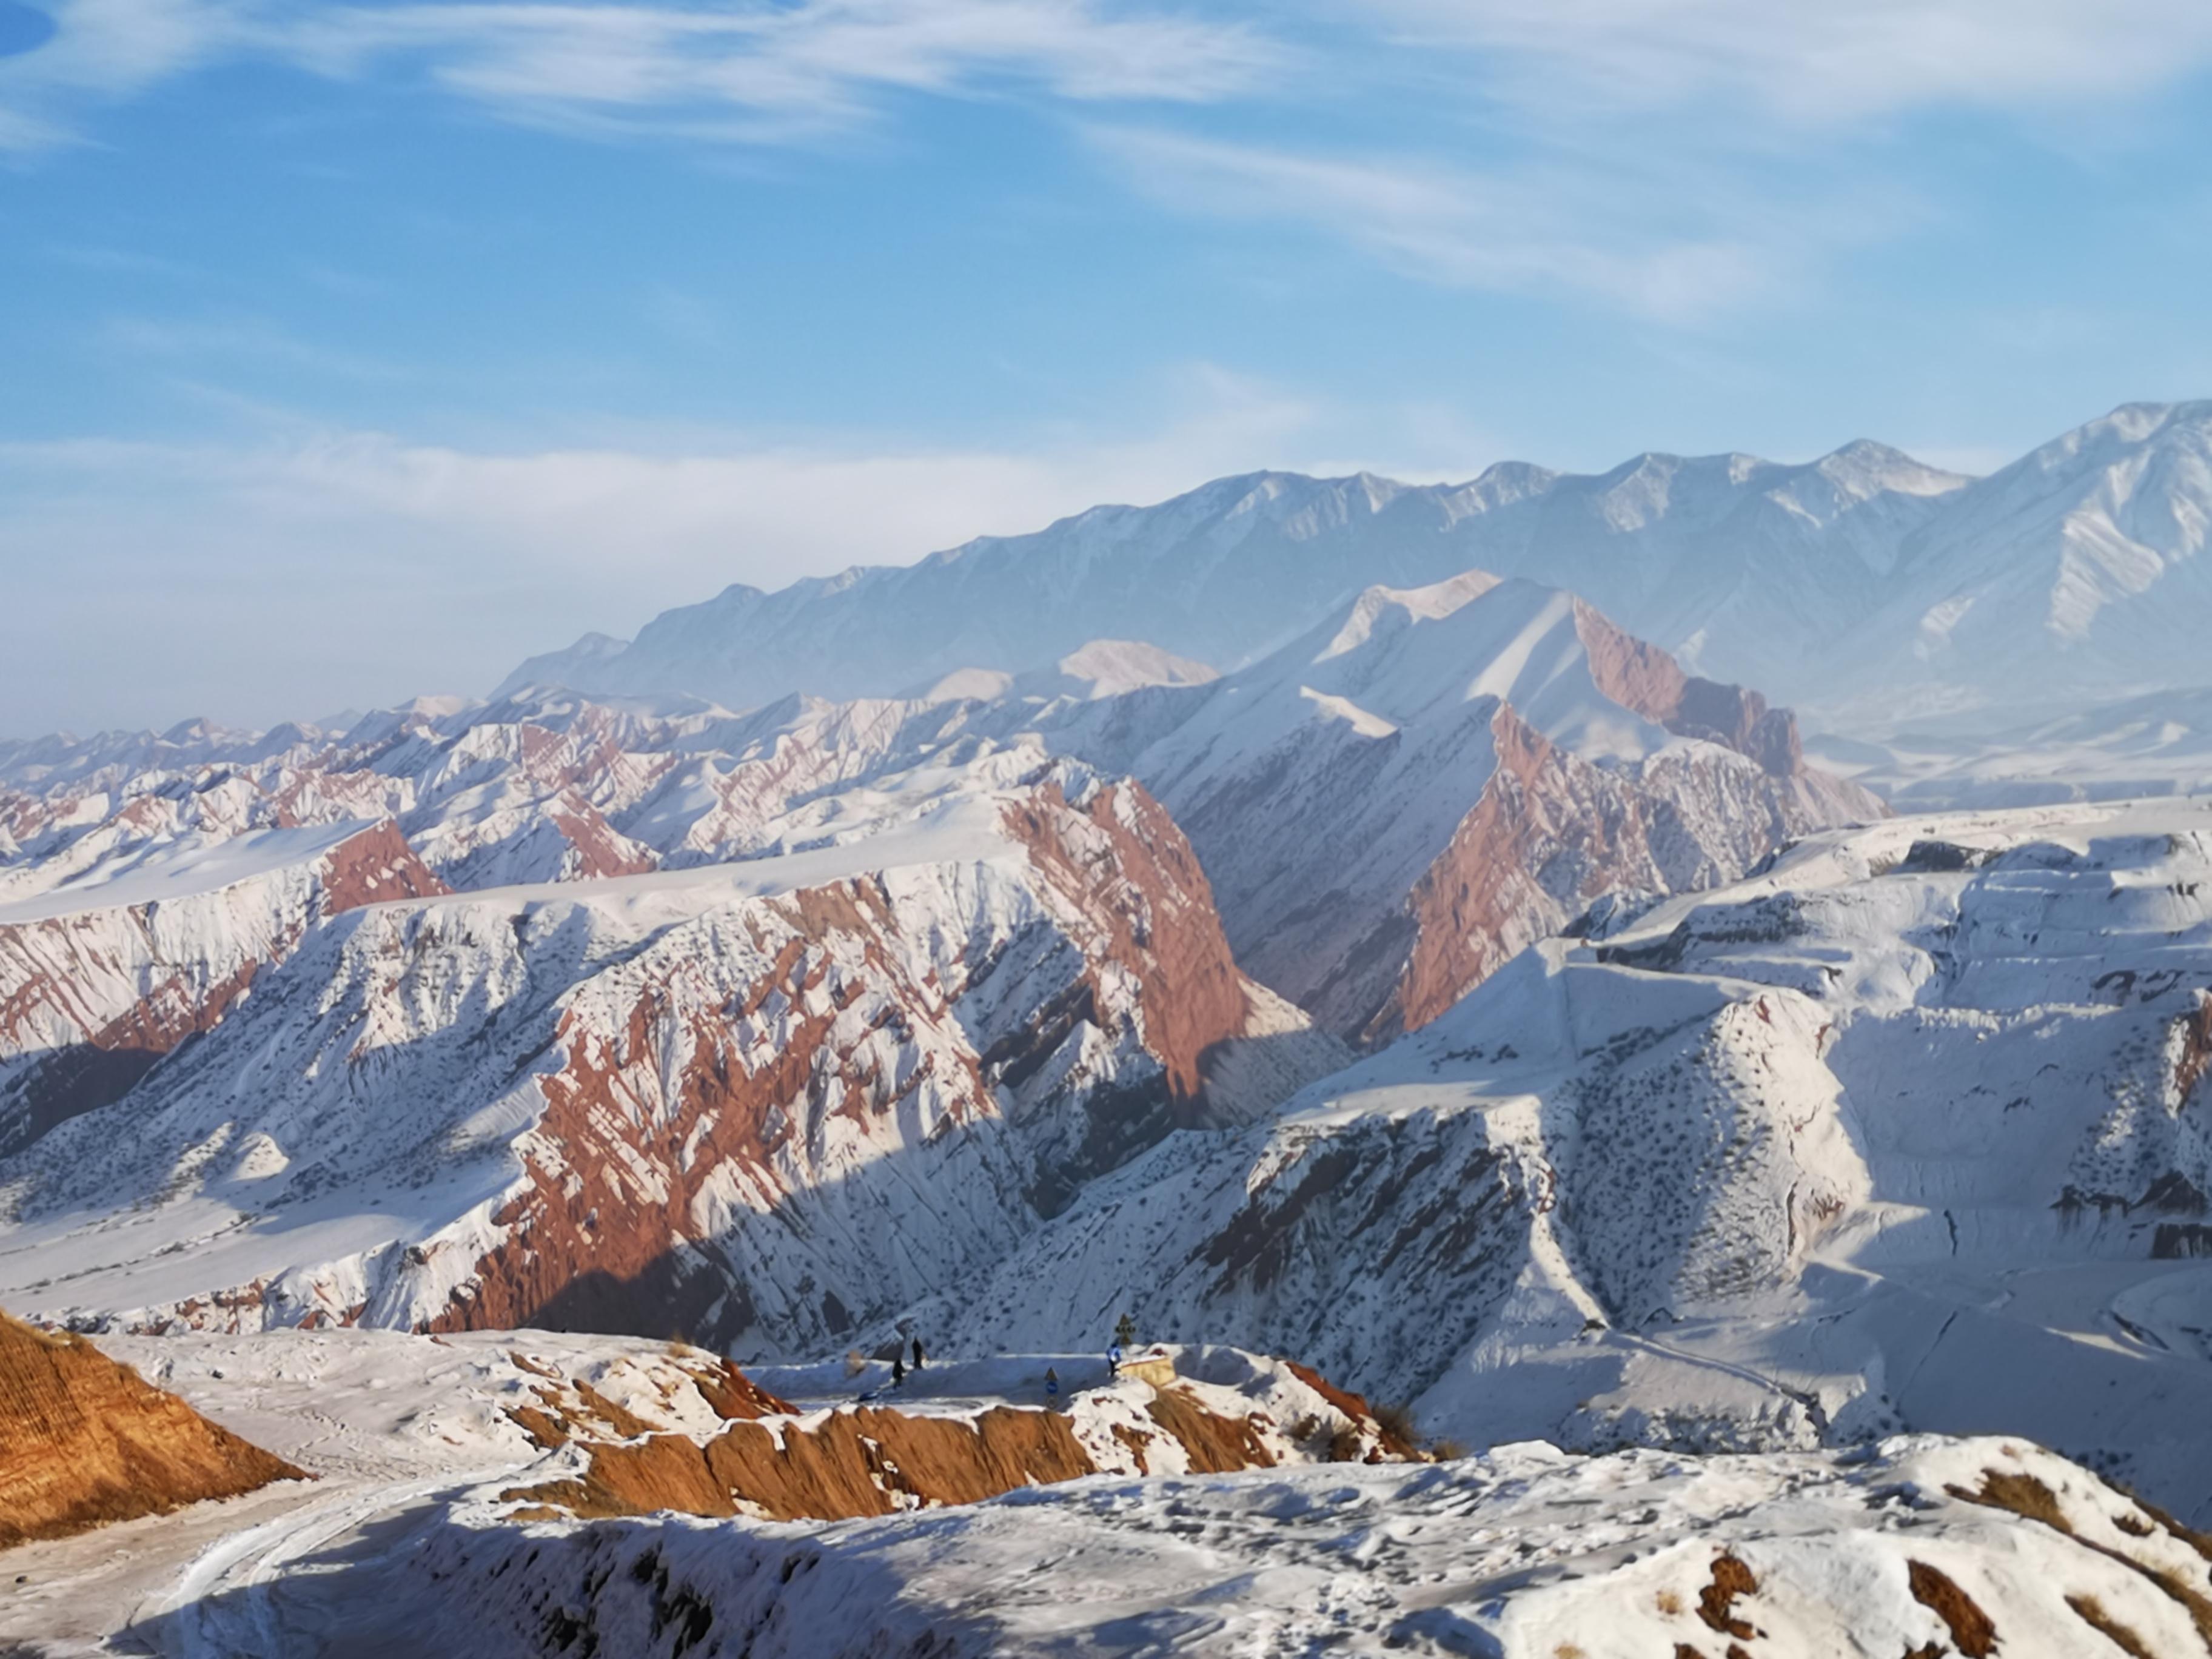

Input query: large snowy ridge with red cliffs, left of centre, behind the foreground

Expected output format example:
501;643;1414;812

0;765;1342;1352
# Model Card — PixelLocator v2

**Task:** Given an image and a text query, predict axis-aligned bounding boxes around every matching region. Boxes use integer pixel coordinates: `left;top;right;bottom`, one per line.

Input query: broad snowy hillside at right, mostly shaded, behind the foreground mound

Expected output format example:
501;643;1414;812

893;803;2212;1513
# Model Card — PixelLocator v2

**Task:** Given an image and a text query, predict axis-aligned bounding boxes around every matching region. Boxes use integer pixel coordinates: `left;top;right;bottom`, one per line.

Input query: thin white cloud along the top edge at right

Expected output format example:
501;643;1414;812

1356;0;2212;126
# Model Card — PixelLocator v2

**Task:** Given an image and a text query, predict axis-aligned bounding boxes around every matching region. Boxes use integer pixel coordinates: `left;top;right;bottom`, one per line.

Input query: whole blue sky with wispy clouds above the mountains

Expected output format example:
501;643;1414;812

0;0;2212;734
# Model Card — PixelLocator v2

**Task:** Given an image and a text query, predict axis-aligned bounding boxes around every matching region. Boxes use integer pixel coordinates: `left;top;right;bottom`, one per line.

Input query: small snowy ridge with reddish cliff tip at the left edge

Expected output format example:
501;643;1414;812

0;820;444;1155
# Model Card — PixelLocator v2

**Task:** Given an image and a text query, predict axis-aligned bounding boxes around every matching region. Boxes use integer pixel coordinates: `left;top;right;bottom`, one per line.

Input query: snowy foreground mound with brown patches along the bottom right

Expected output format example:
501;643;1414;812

407;1440;2212;1659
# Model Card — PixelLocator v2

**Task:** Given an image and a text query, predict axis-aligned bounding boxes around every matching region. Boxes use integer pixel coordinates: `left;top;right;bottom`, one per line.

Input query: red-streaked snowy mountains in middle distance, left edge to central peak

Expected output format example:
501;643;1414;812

0;573;1880;1354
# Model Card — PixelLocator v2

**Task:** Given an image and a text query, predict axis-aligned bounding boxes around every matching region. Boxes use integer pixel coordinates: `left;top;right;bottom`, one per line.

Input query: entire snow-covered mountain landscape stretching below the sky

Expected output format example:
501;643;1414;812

0;405;2212;1659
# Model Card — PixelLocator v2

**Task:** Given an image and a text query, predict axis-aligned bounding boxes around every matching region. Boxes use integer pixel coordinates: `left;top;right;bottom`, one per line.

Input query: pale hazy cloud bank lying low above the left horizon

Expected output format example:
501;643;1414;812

0;369;1345;737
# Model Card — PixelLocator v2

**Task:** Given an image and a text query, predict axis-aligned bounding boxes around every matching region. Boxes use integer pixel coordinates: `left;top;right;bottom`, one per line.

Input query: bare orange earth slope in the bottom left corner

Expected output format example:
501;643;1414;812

0;1314;307;1549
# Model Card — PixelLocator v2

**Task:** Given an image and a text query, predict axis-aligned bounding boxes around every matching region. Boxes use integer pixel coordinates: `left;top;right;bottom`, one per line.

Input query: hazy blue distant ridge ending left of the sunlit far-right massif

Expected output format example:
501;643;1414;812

480;422;1991;708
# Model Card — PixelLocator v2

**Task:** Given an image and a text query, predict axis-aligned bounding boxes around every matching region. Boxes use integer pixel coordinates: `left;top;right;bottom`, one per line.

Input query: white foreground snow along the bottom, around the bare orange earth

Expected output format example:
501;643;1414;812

0;1332;2212;1659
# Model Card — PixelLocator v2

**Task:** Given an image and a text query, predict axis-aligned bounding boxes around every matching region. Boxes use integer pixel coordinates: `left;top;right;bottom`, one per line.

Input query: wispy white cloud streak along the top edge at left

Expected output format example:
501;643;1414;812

0;0;1283;146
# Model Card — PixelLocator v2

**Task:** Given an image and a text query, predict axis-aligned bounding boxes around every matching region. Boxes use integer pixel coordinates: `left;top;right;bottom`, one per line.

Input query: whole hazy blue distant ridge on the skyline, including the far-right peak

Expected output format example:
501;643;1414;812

500;403;2212;723
